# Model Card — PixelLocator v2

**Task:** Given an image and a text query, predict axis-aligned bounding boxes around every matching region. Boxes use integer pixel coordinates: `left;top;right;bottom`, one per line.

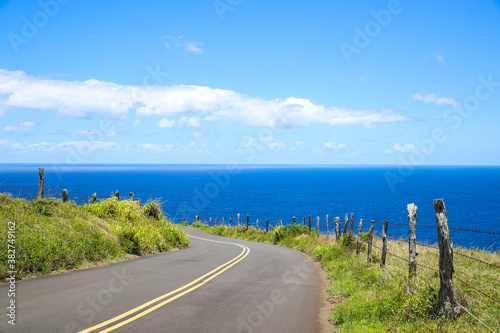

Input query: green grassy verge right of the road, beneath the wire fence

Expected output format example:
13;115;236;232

188;223;500;333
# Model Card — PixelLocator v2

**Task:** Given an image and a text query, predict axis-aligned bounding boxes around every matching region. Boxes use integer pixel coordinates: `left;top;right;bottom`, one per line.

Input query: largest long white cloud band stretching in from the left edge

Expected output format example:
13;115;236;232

0;69;412;128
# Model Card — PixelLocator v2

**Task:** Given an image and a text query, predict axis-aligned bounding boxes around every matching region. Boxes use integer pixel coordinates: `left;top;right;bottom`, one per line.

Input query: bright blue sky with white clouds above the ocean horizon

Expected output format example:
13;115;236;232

0;0;500;165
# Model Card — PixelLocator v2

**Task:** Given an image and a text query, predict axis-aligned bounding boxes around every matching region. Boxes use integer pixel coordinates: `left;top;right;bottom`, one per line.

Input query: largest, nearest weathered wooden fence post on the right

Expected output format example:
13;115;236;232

434;199;455;317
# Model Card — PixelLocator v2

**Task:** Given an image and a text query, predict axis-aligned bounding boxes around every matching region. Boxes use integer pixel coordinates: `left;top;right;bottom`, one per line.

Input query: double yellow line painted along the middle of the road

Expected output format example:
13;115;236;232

79;236;250;333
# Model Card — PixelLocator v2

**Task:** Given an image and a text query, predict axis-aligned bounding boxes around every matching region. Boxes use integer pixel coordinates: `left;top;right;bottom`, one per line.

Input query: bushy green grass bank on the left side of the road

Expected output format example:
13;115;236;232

0;194;189;279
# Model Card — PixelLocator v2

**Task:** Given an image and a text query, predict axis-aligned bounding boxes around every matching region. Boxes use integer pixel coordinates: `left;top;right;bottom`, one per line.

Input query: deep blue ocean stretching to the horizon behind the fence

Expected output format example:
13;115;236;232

0;164;500;251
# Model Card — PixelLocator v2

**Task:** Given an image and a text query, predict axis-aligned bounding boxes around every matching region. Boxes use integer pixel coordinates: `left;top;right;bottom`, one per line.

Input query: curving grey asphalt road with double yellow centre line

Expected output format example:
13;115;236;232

0;229;326;333
